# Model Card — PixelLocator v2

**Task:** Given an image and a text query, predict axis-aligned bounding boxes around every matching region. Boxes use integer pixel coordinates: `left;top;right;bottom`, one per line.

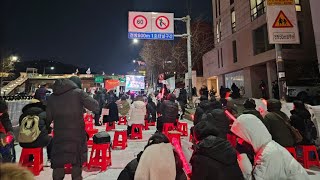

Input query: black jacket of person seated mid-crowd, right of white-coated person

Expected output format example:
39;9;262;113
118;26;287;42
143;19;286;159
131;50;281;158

160;100;179;123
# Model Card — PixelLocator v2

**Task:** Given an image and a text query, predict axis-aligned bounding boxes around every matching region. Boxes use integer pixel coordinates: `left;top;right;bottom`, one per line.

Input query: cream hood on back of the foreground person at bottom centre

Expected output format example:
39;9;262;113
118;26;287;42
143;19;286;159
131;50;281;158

134;143;176;180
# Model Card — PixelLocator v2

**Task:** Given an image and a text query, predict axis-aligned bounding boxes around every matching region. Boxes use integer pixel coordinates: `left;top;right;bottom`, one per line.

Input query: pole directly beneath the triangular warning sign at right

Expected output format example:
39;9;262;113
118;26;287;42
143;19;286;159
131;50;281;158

275;44;286;100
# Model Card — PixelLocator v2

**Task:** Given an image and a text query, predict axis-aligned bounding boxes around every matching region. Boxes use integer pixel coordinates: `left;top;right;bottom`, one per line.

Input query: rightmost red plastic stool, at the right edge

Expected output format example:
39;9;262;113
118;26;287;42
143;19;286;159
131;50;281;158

298;145;320;169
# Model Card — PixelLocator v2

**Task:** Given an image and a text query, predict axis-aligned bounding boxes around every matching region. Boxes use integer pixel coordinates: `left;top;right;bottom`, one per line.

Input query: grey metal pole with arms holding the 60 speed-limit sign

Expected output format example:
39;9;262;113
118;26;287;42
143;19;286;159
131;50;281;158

174;15;192;99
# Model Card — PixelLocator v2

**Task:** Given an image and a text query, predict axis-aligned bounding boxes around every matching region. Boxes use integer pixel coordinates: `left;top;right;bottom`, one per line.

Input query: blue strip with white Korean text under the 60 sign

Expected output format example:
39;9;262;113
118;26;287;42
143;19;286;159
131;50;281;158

128;32;174;40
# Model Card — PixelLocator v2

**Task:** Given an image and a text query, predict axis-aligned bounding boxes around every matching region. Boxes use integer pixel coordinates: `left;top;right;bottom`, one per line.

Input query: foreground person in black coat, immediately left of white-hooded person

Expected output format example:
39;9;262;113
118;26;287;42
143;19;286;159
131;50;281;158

190;121;244;180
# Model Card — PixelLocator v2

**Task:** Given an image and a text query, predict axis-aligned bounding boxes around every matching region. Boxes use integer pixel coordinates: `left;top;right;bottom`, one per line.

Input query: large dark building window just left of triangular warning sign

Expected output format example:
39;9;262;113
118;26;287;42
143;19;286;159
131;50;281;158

253;24;274;55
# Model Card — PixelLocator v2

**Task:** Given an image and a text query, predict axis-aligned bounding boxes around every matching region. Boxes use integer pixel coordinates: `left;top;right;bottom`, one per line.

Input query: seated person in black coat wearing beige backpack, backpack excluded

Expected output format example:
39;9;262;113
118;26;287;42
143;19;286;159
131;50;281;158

19;99;52;166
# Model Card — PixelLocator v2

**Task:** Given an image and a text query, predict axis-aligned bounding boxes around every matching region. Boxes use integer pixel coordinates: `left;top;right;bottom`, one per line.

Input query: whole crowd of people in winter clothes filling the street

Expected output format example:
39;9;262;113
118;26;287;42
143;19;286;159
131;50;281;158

0;76;318;180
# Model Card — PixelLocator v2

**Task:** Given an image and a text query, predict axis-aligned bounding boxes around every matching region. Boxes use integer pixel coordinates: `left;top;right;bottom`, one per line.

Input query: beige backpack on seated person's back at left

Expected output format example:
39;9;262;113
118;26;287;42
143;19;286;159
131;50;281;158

18;115;41;143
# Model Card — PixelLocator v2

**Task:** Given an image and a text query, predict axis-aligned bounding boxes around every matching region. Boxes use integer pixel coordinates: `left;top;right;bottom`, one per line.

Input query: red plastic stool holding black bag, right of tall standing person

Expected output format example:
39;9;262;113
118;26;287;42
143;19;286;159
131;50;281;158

88;143;112;171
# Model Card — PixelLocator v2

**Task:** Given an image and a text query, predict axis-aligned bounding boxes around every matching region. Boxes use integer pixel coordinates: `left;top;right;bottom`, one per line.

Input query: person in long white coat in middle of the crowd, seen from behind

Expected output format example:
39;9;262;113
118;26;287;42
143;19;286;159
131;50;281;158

127;95;147;137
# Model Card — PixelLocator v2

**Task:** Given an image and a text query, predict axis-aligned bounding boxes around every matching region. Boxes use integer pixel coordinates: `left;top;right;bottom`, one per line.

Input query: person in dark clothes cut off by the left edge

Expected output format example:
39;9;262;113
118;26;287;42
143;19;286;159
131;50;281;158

0;100;16;162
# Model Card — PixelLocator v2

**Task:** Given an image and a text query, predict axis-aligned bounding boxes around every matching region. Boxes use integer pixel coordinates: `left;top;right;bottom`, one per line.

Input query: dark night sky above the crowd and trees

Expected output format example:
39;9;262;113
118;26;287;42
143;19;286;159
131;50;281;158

0;0;212;73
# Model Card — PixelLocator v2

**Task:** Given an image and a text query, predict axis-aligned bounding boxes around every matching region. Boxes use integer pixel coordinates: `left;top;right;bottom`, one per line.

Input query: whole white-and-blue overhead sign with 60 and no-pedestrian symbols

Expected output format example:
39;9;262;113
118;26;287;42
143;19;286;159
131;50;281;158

128;12;174;40
